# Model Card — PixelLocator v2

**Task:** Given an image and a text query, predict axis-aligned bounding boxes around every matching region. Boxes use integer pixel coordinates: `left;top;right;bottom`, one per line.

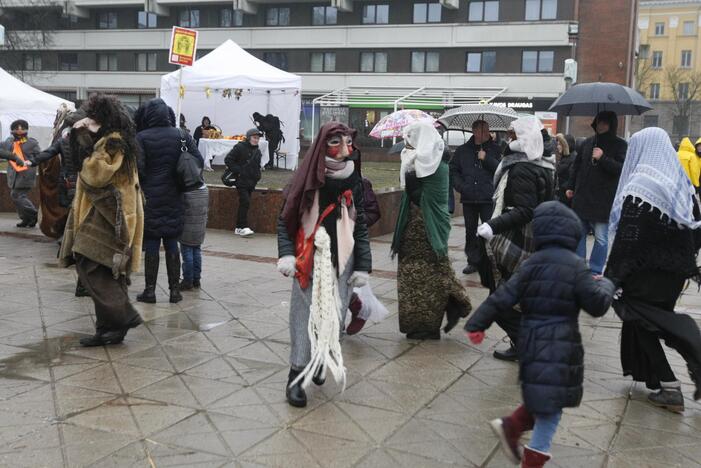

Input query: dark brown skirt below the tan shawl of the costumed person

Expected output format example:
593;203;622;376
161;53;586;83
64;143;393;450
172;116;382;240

75;255;139;333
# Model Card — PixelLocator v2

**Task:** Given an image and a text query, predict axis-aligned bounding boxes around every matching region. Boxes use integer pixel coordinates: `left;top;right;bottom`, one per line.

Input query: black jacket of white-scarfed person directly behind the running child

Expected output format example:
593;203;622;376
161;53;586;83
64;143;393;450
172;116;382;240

489;155;554;234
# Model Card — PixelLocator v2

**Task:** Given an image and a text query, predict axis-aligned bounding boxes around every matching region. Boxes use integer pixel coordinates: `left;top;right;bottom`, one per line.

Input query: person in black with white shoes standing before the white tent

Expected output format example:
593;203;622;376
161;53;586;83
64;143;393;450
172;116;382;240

224;128;263;237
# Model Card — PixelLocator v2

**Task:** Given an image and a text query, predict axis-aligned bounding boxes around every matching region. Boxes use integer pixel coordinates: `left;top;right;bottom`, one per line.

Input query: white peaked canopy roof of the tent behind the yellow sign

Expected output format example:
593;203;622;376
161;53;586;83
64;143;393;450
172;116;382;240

161;39;302;93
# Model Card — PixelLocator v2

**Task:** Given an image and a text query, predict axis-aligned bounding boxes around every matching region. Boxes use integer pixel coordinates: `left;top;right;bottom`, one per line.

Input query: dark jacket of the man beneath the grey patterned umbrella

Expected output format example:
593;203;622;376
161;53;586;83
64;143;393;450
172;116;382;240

450;137;501;204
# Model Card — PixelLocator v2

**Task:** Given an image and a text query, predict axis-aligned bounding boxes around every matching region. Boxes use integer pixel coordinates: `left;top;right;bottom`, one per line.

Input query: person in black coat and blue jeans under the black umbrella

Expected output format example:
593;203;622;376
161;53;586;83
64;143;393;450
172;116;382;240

566;111;628;275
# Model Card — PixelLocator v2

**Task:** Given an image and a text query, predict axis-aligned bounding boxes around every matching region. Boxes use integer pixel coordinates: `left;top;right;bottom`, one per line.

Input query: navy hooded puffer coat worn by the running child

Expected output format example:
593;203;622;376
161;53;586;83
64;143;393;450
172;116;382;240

465;201;614;414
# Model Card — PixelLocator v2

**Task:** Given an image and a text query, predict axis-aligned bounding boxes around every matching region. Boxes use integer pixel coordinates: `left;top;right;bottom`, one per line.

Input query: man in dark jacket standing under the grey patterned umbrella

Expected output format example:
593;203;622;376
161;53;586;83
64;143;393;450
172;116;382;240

450;120;501;275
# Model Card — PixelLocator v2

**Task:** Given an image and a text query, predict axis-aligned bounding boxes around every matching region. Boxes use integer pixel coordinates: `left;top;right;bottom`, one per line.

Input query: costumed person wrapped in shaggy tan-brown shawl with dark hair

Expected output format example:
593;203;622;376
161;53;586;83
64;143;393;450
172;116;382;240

59;94;144;346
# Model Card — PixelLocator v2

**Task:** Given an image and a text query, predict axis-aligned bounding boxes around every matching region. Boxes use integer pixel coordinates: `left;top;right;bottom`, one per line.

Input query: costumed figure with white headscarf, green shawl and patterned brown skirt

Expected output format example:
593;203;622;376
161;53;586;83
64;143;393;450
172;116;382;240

392;123;471;339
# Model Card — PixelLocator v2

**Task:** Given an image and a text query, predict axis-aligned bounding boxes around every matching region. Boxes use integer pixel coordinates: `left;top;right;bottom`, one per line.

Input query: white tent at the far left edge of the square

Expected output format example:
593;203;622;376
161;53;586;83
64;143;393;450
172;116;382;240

0;68;75;146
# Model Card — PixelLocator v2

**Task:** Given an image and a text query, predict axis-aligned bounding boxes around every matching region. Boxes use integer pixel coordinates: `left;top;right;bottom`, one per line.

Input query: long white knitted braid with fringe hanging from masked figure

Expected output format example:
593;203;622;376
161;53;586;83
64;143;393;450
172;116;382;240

290;226;346;390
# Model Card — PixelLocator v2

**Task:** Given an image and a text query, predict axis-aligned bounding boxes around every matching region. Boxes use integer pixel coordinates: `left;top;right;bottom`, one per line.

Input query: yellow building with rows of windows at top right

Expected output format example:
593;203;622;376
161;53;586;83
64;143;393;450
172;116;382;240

634;0;701;140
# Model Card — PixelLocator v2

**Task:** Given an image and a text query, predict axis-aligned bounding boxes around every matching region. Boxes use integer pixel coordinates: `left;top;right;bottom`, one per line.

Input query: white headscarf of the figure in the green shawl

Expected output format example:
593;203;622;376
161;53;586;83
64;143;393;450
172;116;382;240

399;122;445;188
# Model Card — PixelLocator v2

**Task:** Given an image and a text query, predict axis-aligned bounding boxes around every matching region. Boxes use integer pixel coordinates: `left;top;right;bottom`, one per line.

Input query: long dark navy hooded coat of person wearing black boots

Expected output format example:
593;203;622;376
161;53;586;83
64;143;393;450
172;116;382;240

135;99;204;238
